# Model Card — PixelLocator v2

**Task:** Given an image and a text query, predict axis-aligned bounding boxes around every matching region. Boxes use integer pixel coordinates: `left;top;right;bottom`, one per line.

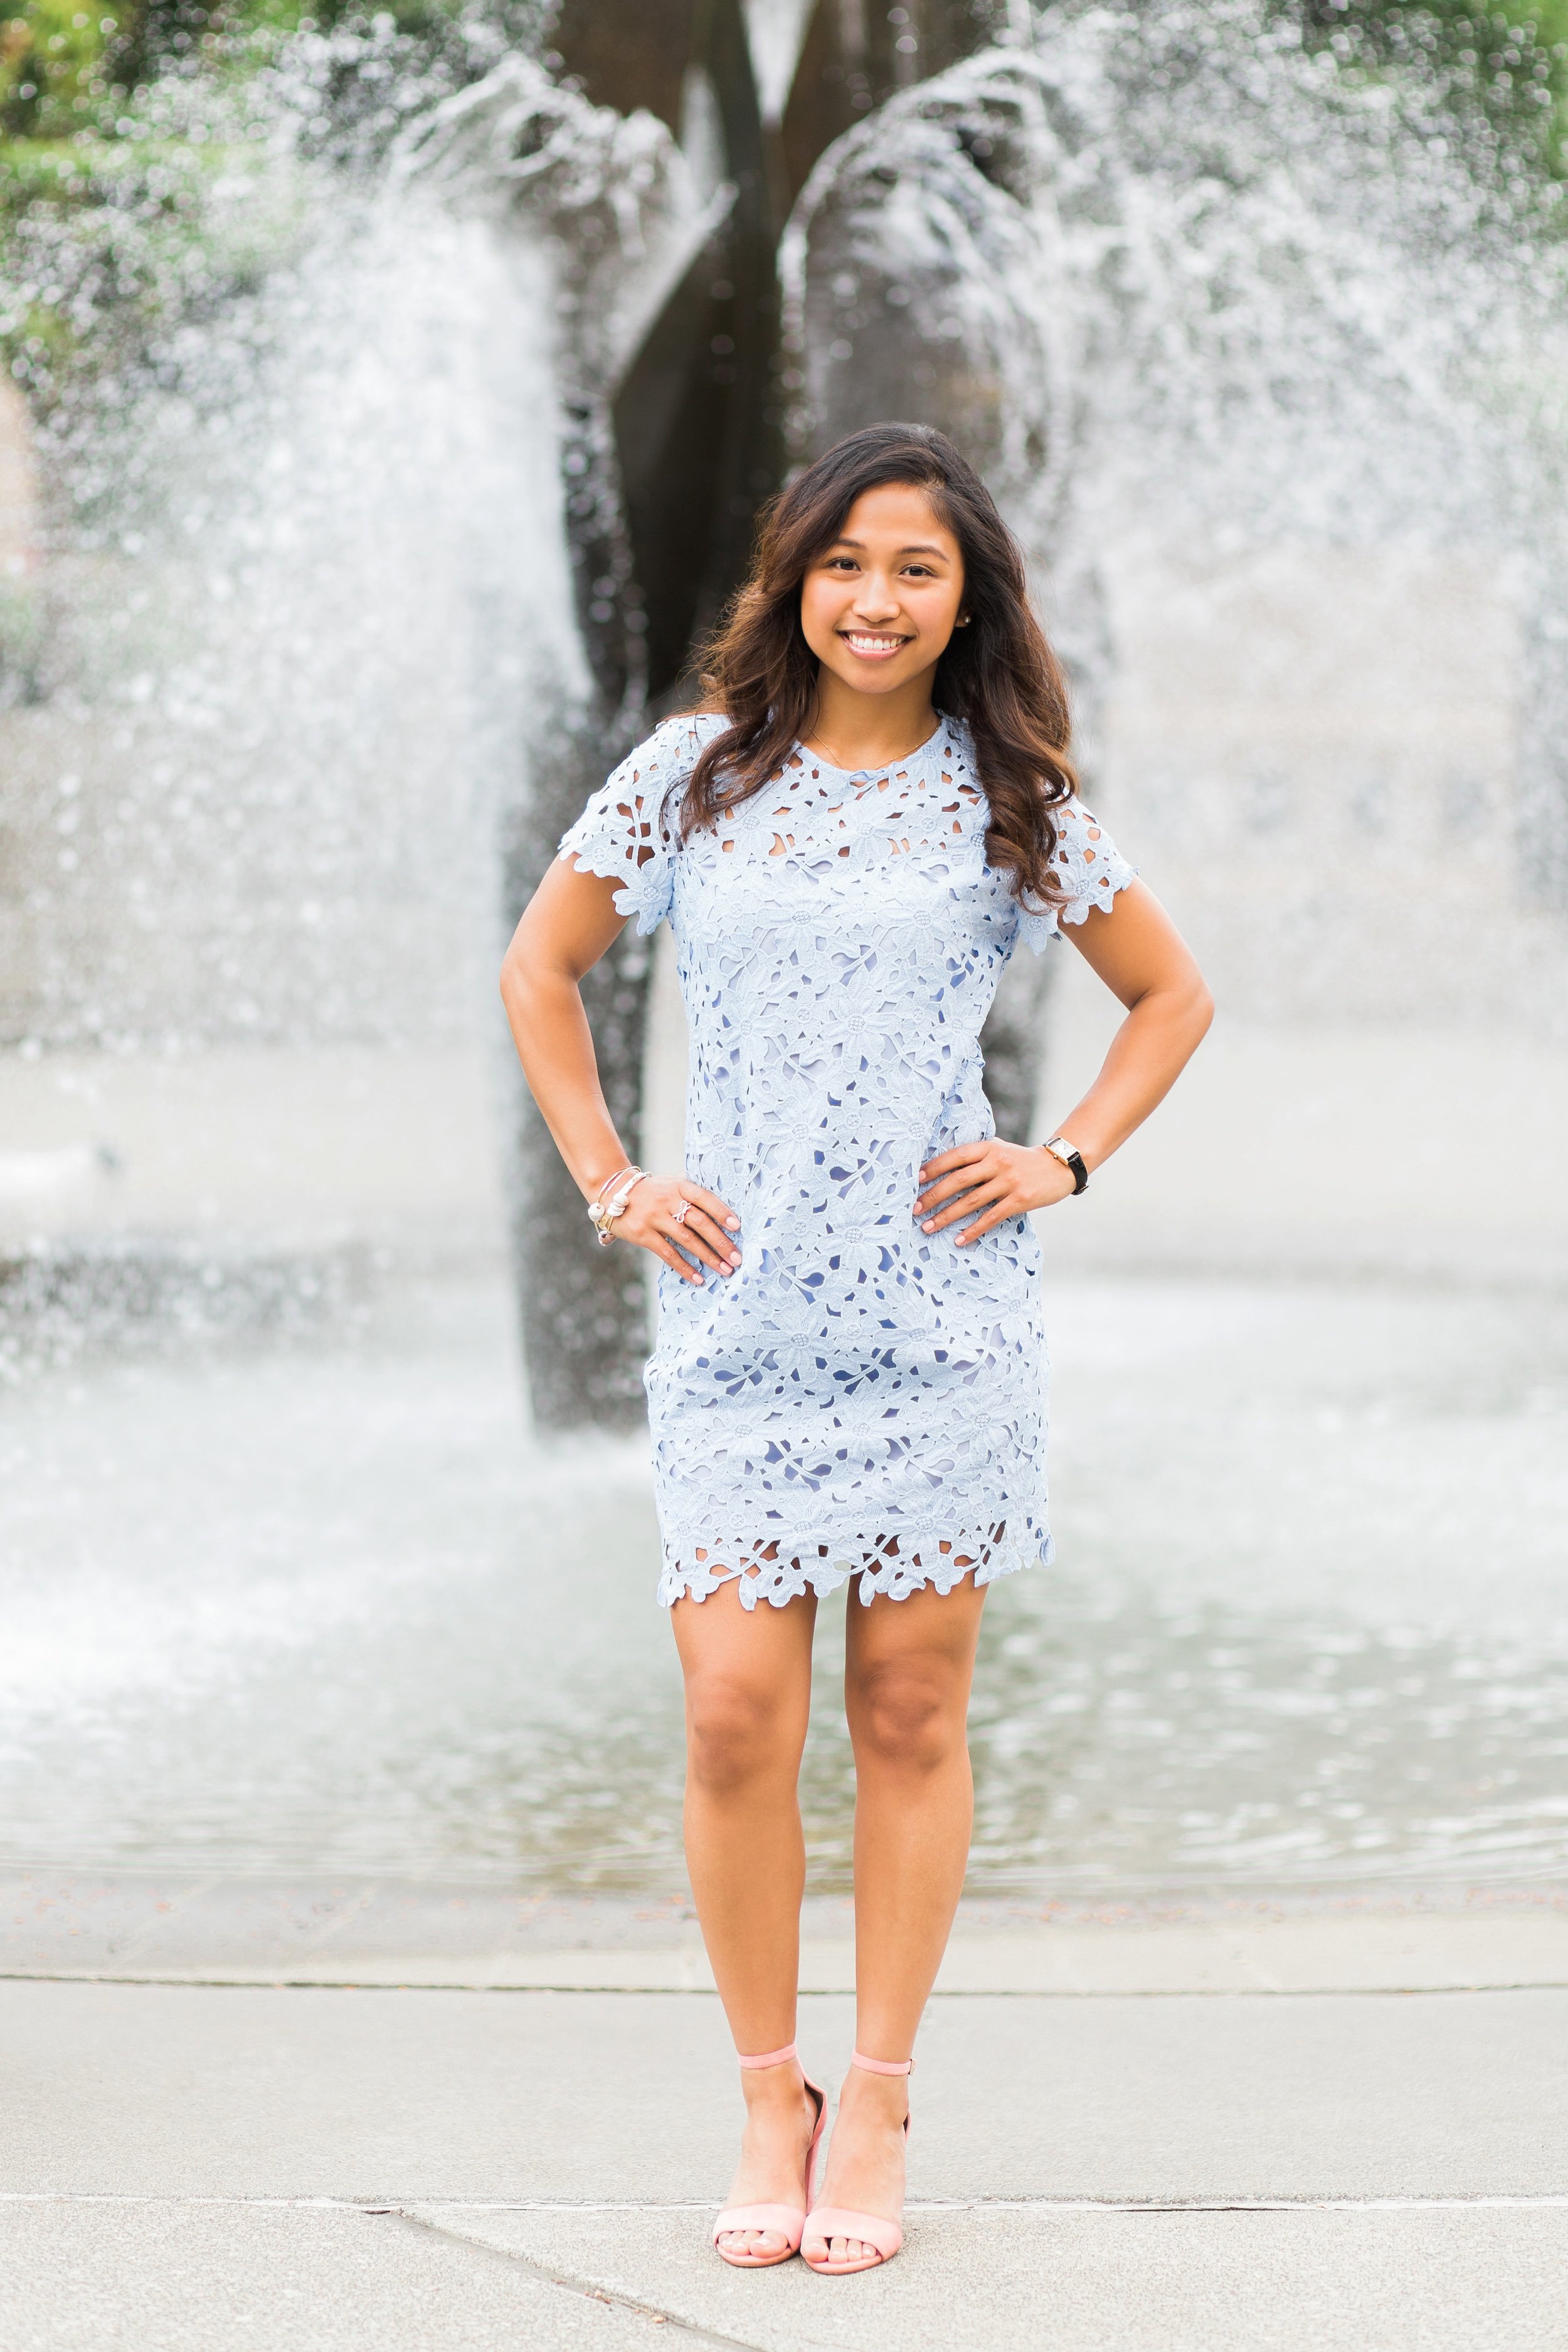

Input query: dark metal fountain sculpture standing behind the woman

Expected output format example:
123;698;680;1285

506;0;1062;1428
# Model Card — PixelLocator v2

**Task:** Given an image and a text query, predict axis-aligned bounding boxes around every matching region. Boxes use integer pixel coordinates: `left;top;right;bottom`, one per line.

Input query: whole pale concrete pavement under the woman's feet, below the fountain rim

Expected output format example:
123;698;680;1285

0;1966;1568;2352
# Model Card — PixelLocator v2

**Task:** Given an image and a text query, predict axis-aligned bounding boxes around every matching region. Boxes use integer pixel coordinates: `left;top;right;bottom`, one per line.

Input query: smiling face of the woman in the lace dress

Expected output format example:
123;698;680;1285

799;482;964;694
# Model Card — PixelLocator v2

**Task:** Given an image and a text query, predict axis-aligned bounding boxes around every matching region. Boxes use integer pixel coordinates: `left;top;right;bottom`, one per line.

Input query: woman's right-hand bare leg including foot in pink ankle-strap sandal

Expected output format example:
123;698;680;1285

807;1583;985;2263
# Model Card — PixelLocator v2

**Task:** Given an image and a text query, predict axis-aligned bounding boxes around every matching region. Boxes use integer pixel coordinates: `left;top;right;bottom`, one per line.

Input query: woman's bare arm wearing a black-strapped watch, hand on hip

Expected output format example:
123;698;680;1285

914;882;1213;1244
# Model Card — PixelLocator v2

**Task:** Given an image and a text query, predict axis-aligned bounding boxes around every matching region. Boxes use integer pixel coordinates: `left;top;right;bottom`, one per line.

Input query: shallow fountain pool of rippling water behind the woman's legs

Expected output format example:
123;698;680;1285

0;1277;1568;1896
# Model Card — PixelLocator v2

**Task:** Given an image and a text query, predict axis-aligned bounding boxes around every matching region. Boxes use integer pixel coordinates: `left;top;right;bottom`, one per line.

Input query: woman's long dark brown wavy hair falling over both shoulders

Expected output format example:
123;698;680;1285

679;423;1077;906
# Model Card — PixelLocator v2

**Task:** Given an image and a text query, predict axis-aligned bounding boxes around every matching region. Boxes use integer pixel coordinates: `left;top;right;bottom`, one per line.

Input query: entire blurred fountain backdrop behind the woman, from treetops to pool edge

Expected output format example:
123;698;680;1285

0;0;1568;1966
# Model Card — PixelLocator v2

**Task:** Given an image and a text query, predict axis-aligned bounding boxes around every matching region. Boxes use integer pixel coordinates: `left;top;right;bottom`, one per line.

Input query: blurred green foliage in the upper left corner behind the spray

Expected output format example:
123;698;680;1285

0;0;543;419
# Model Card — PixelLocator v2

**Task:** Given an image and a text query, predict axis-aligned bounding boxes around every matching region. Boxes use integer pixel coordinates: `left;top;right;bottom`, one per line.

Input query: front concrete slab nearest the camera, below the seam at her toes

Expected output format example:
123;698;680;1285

0;2204;1568;2352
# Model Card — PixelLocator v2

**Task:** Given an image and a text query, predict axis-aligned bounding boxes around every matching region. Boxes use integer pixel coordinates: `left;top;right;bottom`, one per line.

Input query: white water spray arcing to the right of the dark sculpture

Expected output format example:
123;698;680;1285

783;7;1568;1096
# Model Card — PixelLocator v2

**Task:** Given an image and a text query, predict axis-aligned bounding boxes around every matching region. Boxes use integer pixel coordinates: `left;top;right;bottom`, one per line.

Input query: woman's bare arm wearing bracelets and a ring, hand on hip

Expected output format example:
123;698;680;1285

501;859;741;1285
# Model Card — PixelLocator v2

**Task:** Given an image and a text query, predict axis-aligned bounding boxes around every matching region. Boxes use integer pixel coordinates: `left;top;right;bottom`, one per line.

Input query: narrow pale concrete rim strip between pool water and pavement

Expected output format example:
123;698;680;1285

12;1870;1568;1994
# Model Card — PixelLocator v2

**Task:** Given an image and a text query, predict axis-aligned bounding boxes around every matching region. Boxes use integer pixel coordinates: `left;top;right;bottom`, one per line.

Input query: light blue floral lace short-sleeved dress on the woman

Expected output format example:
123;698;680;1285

562;715;1133;1609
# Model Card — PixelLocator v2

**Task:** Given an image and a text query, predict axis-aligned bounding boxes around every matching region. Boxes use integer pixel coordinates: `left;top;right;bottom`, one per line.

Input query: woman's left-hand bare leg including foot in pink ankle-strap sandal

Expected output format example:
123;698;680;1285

672;1583;816;2254
